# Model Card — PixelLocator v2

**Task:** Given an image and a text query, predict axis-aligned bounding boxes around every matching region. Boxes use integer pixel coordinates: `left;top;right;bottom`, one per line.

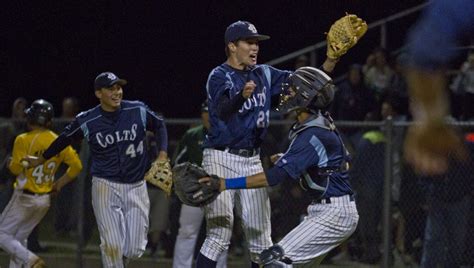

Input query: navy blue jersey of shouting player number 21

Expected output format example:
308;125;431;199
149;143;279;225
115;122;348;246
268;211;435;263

204;63;291;149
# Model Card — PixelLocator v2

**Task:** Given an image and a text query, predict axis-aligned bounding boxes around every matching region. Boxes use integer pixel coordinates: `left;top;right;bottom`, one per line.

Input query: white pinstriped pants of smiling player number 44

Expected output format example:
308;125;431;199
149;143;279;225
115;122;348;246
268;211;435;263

92;177;150;268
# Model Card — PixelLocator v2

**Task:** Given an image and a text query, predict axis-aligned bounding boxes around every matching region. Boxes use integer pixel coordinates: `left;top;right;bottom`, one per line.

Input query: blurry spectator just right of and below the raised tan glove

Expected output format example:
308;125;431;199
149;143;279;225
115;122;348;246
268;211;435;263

365;47;394;101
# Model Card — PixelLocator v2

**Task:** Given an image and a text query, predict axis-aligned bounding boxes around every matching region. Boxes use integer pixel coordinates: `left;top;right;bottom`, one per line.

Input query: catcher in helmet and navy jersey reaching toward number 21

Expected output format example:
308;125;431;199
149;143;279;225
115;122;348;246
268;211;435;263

201;67;359;267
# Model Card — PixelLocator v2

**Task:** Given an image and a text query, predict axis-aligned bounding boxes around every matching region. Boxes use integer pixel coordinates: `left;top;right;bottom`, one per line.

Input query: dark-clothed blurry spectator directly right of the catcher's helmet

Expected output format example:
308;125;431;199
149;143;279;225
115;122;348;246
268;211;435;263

330;64;375;148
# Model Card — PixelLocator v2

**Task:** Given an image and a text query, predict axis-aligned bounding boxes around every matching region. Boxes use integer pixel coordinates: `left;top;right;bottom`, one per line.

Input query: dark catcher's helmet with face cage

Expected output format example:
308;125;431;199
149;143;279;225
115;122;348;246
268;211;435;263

277;66;335;112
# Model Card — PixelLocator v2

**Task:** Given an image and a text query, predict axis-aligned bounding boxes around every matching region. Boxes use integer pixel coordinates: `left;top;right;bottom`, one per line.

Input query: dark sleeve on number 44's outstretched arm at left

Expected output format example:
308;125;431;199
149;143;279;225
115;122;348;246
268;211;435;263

43;117;84;159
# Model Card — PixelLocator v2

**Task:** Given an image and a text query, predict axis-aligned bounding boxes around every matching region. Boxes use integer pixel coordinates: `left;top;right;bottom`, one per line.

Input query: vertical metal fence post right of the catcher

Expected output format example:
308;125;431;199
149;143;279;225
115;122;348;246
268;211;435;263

382;117;393;268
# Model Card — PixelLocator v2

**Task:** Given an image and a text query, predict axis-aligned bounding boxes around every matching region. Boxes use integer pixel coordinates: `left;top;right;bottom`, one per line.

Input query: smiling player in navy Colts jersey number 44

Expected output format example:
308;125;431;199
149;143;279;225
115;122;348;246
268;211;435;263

27;72;168;268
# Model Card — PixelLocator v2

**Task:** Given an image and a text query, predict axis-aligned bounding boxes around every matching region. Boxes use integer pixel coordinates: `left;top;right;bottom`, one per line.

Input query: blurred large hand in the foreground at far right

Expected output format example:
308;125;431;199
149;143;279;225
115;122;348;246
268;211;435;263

404;122;467;175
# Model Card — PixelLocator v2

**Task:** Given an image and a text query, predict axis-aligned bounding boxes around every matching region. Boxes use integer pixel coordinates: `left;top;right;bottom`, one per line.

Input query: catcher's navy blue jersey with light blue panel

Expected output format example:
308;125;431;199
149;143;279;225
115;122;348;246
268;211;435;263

276;120;352;198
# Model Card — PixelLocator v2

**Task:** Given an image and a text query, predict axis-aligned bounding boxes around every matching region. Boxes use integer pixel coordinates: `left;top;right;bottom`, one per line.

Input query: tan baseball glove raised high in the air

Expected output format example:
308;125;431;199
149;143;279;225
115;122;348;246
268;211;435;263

326;13;367;59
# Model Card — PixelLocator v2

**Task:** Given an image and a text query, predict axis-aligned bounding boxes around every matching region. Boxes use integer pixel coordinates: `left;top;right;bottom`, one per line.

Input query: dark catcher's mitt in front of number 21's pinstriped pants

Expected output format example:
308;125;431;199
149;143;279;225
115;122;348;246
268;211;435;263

173;162;220;207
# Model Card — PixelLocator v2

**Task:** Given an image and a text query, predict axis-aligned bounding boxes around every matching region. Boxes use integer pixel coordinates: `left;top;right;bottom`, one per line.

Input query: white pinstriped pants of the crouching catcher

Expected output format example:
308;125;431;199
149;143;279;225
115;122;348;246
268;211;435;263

278;195;359;264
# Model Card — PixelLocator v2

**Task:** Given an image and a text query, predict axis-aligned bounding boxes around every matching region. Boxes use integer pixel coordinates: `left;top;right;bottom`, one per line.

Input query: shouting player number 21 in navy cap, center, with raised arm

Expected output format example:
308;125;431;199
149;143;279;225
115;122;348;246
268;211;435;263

197;21;352;267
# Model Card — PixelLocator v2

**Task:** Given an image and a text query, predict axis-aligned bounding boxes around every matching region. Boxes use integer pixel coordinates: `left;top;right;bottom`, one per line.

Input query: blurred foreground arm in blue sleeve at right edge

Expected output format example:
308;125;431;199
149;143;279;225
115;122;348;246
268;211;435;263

404;0;474;175
